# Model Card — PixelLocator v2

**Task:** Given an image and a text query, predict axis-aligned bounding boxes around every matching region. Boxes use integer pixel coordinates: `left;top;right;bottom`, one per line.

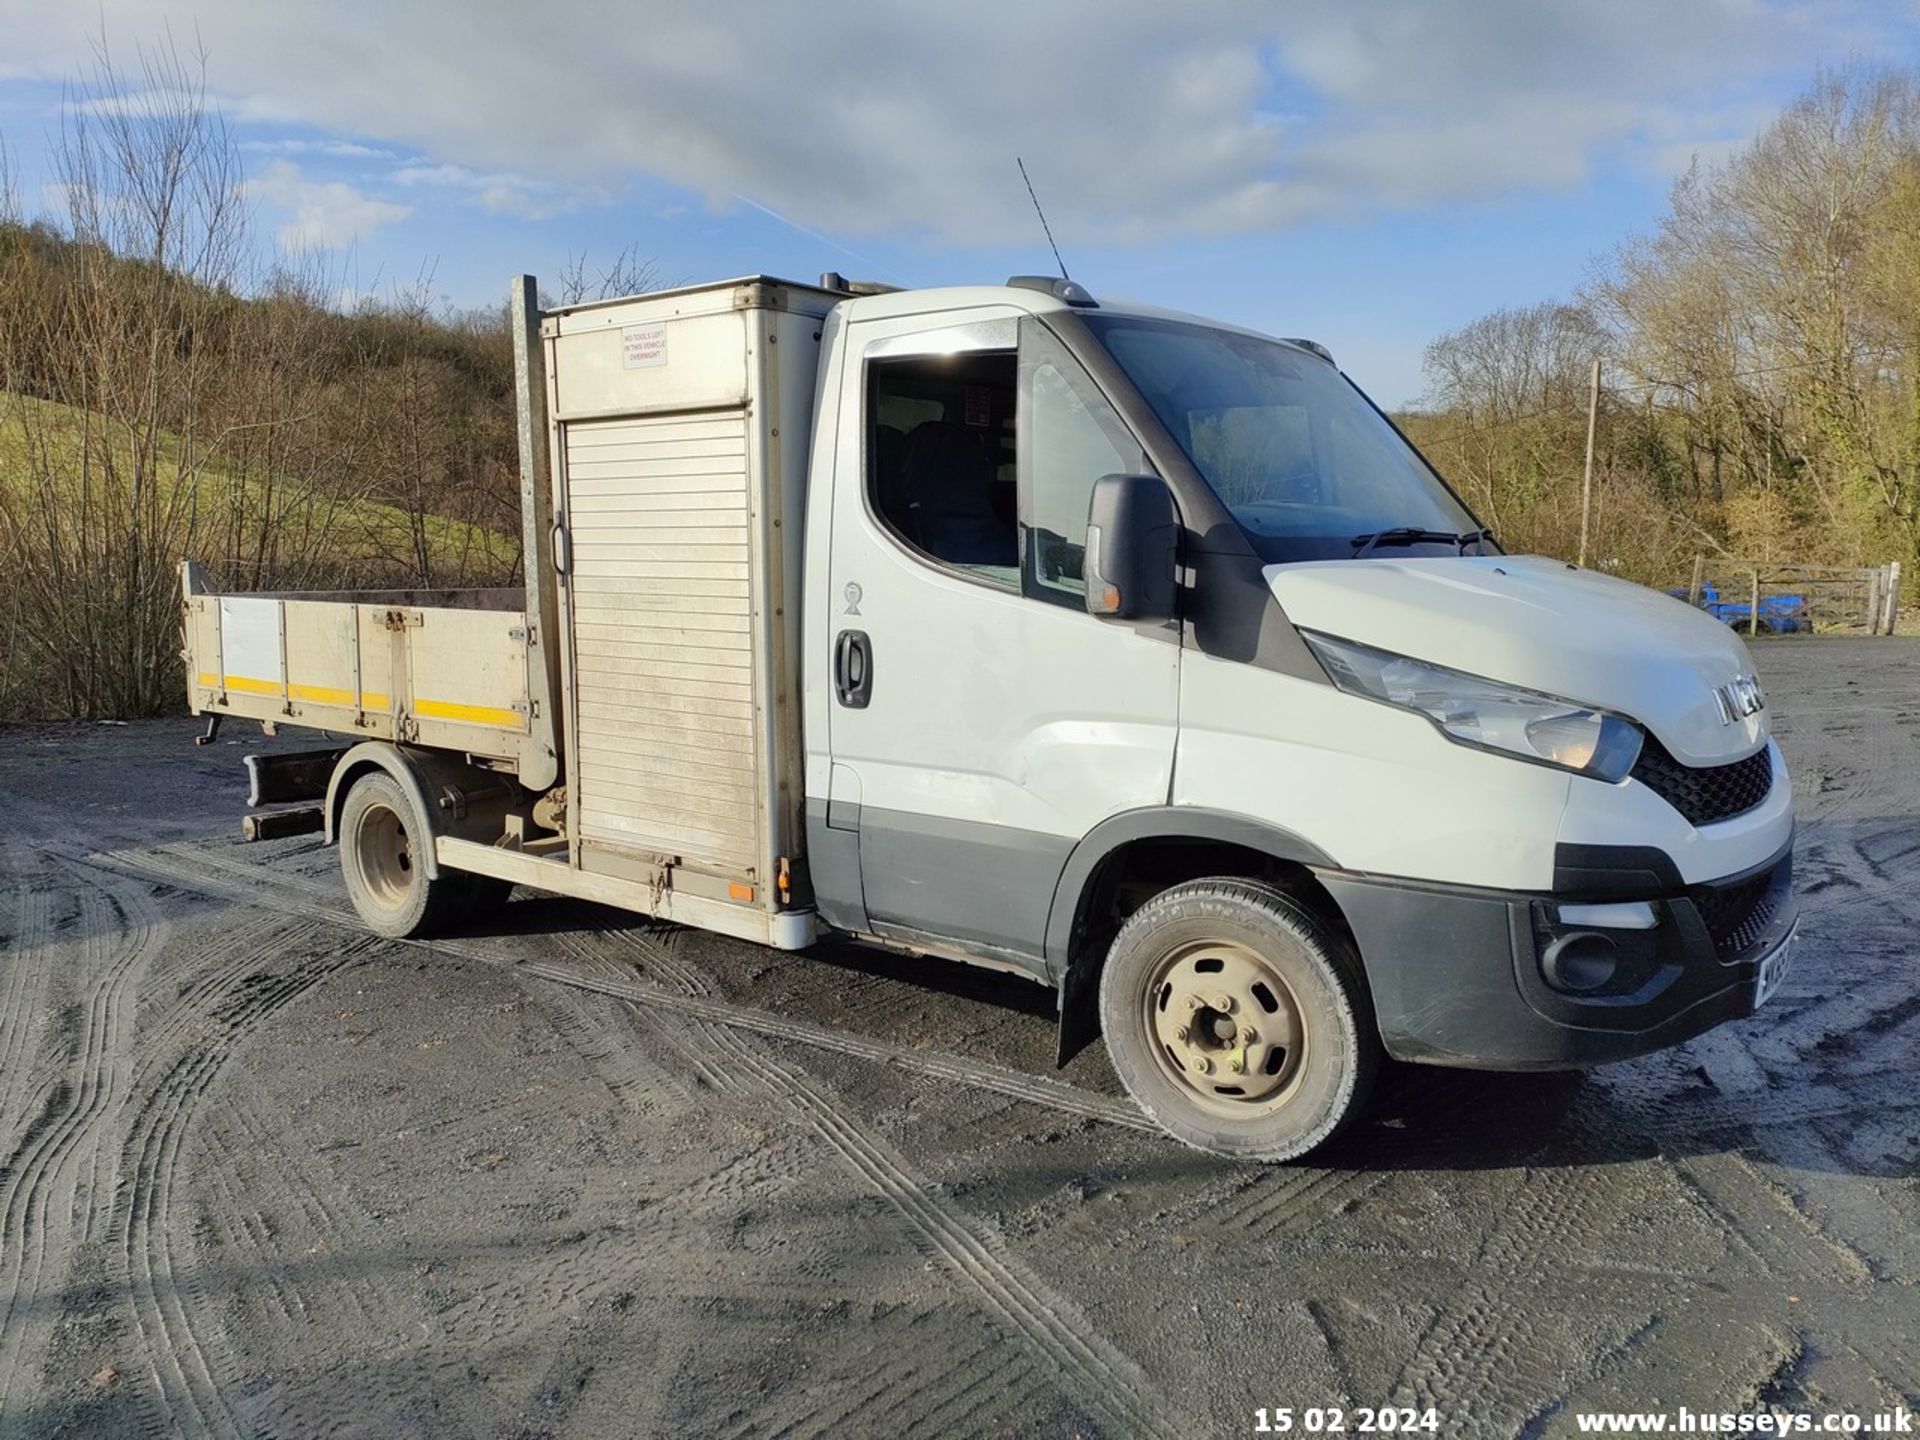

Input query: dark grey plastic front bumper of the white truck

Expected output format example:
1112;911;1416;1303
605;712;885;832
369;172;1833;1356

1321;839;1799;1069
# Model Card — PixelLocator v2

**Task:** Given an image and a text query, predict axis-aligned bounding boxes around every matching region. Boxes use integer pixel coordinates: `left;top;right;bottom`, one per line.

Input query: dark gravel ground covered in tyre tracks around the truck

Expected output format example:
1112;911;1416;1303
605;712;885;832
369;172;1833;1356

0;639;1920;1440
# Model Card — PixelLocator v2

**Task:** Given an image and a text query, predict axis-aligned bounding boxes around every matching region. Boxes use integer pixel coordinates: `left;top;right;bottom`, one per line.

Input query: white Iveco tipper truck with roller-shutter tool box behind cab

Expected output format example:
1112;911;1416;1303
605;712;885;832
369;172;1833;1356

184;276;1795;1160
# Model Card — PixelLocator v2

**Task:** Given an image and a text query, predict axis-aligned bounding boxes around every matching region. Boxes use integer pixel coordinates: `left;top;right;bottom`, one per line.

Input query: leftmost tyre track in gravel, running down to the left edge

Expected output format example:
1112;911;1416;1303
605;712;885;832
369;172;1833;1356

0;868;167;1423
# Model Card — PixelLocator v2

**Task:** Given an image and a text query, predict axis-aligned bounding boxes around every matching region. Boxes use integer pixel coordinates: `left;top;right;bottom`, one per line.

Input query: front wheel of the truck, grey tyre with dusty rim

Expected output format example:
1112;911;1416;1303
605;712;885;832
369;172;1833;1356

1100;879;1380;1162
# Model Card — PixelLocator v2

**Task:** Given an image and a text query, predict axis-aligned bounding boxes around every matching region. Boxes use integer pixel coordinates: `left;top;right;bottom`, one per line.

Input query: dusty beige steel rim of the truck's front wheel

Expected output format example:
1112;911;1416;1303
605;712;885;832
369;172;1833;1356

1142;941;1309;1119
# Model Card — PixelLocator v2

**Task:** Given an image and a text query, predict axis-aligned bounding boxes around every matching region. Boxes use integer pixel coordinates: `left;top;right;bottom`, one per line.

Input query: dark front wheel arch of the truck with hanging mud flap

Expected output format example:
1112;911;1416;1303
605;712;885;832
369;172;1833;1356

1046;804;1346;1066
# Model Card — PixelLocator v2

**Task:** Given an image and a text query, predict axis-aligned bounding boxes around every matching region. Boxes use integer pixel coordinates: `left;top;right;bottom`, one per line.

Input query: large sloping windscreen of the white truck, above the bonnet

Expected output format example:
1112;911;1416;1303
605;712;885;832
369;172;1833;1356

1085;315;1478;561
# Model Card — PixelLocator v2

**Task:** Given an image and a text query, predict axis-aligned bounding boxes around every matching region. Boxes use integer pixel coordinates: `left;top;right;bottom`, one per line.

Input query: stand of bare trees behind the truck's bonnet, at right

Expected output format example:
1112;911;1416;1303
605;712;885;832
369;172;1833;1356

1413;65;1920;580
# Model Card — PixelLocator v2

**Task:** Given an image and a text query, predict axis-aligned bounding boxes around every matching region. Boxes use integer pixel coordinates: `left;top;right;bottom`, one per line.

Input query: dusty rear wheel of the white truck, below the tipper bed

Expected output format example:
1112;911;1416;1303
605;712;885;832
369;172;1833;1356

340;770;478;941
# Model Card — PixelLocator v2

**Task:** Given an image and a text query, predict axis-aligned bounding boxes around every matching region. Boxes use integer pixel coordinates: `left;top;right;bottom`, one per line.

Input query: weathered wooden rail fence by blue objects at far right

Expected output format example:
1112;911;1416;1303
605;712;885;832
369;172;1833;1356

1668;555;1901;636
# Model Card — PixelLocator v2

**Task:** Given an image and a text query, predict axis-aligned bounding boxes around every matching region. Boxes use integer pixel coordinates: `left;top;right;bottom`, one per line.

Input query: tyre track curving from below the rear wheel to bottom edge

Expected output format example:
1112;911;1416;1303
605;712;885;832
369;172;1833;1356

113;927;374;1436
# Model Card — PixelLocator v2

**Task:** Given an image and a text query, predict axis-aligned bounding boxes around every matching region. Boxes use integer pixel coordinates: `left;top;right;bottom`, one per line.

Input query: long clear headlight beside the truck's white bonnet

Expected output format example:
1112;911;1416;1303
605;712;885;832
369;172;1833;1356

1300;630;1642;781
